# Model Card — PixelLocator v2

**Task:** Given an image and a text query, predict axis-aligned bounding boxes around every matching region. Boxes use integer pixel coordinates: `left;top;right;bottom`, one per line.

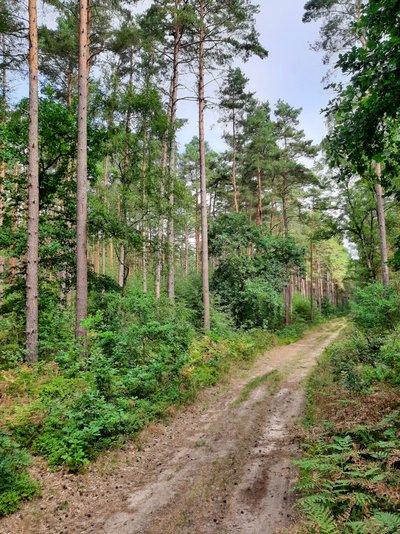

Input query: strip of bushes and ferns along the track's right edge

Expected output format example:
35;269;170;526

296;283;400;534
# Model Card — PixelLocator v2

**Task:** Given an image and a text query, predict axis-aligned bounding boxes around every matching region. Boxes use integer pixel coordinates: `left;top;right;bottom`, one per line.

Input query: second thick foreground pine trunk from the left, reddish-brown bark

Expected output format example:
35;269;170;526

75;0;89;346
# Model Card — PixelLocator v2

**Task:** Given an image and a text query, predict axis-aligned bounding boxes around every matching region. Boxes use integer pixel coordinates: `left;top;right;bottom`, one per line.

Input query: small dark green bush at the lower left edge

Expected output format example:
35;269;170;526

0;430;39;516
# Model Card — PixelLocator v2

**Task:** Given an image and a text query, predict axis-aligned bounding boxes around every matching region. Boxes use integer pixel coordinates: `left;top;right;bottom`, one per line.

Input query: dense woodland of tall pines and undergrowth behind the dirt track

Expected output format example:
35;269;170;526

0;0;400;528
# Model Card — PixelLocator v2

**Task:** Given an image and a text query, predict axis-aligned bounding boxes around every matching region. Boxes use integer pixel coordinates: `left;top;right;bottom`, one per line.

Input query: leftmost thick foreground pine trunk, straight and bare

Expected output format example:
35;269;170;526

26;0;39;363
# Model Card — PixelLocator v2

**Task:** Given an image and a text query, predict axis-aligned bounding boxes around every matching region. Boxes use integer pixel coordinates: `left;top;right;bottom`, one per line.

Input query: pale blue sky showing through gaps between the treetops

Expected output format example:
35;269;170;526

14;0;328;151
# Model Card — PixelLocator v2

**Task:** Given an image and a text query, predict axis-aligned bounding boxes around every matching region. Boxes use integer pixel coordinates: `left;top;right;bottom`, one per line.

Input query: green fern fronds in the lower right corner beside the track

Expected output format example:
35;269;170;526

295;413;400;533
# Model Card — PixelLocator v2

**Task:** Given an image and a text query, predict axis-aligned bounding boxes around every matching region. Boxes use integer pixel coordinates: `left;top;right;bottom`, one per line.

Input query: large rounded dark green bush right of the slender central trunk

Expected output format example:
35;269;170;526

210;214;303;328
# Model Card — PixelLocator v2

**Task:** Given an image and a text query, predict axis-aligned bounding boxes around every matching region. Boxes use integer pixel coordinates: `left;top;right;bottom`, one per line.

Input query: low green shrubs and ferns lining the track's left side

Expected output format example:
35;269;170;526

0;288;276;480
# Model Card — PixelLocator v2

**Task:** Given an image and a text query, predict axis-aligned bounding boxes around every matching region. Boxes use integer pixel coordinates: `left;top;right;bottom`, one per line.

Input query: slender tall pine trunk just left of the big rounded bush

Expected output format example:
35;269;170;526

199;0;211;330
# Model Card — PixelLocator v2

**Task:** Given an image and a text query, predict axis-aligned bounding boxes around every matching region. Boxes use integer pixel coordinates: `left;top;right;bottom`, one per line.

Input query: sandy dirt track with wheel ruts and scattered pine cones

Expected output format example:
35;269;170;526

0;320;343;534
